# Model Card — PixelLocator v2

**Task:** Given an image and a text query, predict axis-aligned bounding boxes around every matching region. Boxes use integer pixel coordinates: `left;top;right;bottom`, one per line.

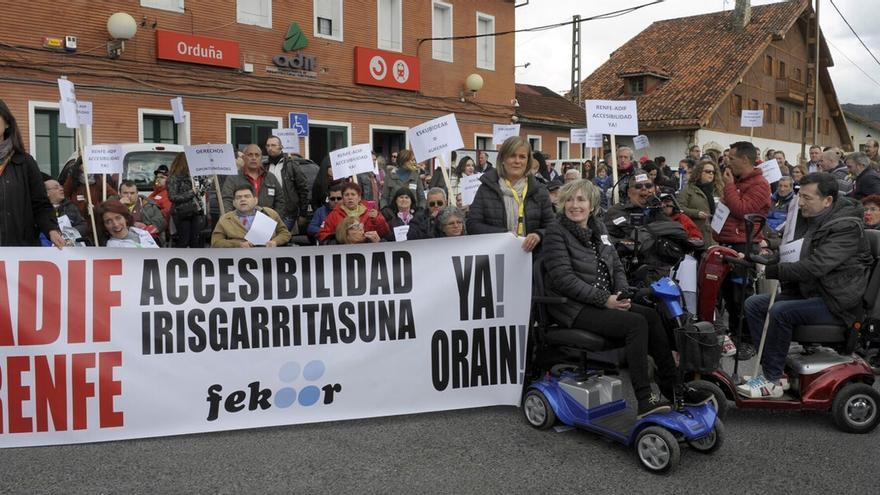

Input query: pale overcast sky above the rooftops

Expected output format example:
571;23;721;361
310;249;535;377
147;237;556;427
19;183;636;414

516;0;880;105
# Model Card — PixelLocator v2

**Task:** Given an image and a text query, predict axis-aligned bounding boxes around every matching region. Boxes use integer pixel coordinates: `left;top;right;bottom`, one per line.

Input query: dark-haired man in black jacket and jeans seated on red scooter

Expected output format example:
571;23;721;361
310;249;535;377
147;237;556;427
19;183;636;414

737;173;872;399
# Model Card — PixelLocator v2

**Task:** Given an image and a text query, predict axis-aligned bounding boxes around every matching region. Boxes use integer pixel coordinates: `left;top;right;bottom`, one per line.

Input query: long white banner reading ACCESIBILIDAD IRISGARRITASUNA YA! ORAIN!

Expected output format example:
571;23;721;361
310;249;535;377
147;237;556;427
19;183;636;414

0;234;531;447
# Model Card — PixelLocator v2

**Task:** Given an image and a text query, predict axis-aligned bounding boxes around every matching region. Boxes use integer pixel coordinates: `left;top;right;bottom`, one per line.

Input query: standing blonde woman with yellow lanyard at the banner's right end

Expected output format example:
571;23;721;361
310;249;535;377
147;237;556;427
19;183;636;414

467;136;555;251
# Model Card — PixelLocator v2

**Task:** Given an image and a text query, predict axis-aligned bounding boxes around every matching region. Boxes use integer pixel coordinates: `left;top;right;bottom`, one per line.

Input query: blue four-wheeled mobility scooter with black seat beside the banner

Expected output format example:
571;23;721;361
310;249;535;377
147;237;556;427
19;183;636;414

522;261;724;473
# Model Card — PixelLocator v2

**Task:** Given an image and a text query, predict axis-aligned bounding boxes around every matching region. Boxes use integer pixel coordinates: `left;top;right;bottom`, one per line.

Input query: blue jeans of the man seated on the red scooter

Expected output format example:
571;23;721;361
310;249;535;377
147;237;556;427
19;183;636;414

745;294;844;381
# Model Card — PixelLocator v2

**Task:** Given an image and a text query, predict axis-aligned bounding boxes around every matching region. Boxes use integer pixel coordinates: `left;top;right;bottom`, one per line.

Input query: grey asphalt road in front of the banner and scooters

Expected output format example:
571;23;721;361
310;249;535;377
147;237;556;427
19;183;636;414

0;362;880;494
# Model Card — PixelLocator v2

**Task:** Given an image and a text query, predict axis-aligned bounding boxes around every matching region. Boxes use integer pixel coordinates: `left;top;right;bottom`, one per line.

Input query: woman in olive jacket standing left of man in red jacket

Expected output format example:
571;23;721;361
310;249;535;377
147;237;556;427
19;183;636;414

678;158;724;247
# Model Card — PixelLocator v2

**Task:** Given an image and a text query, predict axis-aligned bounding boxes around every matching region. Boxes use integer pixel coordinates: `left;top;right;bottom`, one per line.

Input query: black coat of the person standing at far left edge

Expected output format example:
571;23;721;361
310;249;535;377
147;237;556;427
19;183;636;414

0;152;58;246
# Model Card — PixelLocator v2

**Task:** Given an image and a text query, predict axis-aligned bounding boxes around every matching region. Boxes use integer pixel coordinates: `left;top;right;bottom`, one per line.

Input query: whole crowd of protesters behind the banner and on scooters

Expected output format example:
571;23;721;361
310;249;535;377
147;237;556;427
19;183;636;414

0;94;880;415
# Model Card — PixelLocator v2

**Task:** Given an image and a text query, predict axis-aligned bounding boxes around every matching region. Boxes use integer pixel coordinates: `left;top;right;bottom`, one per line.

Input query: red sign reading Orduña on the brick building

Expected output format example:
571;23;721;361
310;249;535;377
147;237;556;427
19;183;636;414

156;31;241;69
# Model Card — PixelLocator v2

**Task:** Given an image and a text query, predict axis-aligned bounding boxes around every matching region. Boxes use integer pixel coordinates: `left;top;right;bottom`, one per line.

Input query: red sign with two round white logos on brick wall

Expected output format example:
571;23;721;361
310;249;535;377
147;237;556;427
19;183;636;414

354;46;420;91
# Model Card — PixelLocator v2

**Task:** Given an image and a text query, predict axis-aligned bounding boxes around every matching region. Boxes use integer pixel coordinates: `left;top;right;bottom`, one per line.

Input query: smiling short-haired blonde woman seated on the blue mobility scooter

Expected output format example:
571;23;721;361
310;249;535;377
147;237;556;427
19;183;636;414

543;180;711;418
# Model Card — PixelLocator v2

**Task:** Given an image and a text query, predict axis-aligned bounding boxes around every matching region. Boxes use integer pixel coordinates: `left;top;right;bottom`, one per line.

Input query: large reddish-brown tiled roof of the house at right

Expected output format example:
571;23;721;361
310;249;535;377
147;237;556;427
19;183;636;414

581;0;807;130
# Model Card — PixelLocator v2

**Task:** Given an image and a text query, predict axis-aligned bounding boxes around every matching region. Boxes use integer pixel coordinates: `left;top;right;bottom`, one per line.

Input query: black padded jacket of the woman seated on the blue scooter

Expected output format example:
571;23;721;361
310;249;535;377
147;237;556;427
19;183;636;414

542;218;627;327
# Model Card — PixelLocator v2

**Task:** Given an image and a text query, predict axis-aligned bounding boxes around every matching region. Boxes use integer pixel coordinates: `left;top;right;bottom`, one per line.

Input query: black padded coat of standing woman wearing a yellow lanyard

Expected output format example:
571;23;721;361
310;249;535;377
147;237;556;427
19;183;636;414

467;168;556;239
